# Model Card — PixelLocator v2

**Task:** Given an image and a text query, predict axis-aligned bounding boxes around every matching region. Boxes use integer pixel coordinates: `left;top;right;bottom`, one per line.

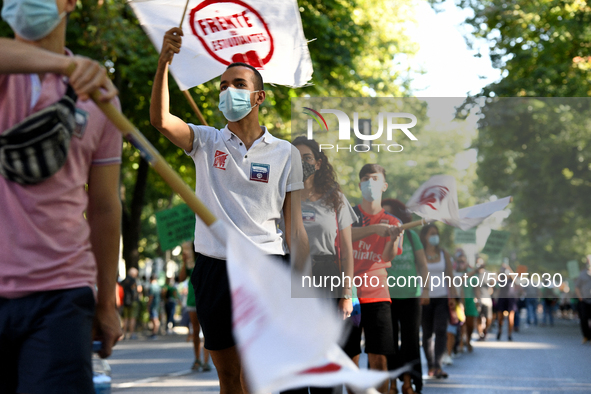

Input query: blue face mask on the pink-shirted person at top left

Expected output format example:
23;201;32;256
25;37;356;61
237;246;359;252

2;0;66;41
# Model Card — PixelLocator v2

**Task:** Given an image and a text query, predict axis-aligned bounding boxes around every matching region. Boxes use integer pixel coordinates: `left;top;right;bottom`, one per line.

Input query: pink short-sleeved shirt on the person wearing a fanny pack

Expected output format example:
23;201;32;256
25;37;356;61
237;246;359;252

0;67;122;298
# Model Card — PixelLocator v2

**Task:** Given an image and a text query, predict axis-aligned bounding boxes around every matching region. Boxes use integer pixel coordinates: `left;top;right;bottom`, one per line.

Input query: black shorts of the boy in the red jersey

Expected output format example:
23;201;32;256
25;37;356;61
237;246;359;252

343;302;396;357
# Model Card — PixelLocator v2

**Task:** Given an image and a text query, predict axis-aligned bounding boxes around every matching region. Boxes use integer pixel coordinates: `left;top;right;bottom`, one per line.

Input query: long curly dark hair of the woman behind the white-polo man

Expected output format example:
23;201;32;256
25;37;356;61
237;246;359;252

292;135;343;212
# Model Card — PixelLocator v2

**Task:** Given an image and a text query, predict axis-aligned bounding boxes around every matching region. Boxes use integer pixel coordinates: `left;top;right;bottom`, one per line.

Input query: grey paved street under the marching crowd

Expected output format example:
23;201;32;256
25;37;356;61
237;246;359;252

109;319;591;394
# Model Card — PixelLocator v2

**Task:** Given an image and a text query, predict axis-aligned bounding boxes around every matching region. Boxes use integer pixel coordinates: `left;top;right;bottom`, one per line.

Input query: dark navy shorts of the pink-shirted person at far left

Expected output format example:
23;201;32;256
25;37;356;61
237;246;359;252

0;287;95;394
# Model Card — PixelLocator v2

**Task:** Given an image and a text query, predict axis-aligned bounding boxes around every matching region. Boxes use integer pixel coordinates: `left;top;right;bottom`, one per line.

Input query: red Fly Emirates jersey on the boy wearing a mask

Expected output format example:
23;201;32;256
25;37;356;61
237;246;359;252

353;205;403;304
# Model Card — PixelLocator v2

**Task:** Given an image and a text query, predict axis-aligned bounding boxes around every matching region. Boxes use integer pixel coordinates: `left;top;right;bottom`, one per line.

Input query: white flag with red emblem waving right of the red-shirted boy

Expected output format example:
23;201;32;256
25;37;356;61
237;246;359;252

406;175;511;230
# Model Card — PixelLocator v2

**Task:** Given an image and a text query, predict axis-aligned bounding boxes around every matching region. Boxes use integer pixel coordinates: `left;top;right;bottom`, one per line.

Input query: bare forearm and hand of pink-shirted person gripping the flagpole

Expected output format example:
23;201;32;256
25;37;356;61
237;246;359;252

0;38;118;101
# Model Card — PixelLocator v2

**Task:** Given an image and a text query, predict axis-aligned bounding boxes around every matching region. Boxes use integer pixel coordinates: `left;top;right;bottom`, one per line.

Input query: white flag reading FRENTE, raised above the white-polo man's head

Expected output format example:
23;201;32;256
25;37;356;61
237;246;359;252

129;0;312;90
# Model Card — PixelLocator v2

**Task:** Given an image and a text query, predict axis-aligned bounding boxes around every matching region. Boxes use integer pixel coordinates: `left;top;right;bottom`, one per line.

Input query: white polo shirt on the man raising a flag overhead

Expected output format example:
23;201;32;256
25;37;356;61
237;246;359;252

186;124;304;259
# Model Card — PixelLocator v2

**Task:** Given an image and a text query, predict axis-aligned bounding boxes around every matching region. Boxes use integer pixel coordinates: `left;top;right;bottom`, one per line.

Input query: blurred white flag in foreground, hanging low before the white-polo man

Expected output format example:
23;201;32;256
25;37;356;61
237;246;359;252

210;220;410;393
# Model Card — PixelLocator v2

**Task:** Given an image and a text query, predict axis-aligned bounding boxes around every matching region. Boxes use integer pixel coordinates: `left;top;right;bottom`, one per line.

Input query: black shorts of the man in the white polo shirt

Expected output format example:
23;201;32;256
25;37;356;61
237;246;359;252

191;253;289;350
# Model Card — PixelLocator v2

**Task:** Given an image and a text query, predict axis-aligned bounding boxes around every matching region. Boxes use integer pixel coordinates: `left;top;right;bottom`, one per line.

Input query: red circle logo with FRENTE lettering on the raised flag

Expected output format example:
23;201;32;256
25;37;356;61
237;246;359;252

189;0;274;69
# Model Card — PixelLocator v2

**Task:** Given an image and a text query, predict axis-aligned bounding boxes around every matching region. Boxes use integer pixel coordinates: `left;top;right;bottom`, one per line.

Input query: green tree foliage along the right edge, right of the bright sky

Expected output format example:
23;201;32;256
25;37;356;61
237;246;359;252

432;0;591;269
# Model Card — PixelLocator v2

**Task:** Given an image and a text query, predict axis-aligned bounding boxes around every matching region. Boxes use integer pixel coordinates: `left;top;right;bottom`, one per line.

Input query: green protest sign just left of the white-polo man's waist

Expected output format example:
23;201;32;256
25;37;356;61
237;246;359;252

156;204;195;250
